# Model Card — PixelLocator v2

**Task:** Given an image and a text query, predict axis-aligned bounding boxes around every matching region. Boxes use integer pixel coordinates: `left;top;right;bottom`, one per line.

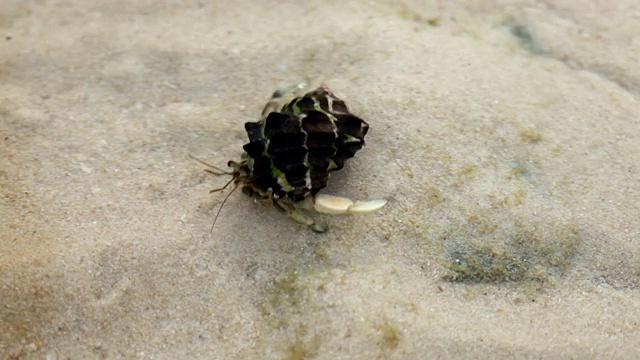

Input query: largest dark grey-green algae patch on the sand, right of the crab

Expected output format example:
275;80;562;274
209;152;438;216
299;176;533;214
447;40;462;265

445;214;580;283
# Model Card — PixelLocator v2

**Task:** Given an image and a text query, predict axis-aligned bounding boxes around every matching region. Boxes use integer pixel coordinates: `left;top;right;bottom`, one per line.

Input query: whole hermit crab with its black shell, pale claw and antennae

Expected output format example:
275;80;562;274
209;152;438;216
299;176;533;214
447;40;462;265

194;85;387;232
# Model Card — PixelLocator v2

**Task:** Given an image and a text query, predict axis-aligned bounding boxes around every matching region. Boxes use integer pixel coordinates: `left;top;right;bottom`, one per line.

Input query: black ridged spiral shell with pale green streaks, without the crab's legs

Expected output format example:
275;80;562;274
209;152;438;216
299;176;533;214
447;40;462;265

243;87;369;202
